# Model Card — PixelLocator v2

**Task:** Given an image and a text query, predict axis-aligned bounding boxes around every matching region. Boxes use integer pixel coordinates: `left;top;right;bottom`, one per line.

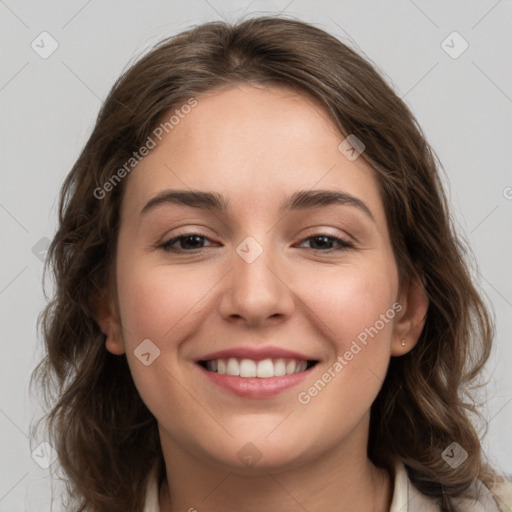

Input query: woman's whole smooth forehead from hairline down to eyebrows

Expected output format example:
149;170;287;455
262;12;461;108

119;84;382;224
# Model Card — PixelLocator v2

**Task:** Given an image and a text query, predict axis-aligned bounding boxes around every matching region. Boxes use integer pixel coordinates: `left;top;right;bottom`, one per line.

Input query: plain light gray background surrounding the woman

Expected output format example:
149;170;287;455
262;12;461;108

0;0;512;512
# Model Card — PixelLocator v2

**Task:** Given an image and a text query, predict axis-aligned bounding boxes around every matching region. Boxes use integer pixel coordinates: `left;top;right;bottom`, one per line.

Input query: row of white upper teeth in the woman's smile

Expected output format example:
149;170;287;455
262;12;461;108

206;357;308;379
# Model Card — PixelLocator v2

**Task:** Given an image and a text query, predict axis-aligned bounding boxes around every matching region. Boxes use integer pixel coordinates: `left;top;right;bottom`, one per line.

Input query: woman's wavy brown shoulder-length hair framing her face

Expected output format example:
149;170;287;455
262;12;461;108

31;16;504;512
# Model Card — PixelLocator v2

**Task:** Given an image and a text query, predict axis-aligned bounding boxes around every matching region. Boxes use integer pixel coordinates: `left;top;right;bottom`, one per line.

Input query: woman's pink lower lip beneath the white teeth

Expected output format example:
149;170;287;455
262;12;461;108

197;364;316;398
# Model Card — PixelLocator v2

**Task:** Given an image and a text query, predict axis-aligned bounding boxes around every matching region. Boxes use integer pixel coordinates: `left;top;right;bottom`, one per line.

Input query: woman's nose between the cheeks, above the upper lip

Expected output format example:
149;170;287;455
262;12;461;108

219;239;295;327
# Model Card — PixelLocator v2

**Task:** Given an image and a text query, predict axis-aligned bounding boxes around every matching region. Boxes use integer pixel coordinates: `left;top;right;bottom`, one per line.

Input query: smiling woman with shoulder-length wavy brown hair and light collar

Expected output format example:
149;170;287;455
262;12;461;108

34;17;512;512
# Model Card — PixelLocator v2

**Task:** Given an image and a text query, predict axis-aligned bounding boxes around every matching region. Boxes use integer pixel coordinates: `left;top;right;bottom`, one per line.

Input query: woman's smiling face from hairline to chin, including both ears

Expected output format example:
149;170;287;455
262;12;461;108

102;84;426;471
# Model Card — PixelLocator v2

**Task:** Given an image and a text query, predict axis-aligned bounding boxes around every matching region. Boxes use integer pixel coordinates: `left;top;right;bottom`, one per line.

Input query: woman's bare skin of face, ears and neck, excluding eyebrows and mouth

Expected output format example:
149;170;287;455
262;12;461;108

98;83;428;512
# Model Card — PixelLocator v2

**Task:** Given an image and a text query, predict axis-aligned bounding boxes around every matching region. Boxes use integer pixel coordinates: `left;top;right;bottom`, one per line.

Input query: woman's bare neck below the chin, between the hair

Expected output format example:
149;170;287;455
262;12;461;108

160;418;393;512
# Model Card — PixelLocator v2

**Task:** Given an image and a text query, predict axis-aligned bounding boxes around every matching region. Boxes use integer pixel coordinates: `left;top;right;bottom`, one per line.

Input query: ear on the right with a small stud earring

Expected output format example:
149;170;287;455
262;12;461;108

391;277;429;356
